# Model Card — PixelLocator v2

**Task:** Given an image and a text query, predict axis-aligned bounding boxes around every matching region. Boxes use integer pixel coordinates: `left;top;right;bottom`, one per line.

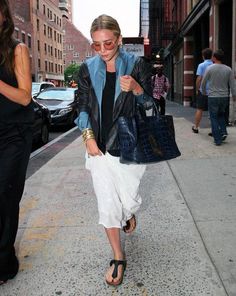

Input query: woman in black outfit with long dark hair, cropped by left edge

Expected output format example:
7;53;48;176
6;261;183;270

0;0;34;285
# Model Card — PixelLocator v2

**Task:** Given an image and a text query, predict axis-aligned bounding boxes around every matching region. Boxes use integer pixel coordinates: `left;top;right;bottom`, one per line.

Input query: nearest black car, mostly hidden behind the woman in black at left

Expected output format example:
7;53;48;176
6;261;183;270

33;99;51;145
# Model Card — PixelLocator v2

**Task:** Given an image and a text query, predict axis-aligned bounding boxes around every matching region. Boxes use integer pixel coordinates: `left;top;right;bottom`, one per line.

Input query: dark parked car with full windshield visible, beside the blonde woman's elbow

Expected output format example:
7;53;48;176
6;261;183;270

35;87;78;126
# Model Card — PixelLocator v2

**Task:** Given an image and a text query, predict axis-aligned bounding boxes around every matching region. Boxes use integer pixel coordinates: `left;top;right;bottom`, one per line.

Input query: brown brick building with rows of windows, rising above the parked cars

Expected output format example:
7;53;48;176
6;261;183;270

30;0;64;86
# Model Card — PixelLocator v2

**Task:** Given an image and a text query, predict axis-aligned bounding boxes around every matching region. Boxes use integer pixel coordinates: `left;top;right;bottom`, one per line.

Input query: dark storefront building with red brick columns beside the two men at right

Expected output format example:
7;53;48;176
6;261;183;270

145;0;236;120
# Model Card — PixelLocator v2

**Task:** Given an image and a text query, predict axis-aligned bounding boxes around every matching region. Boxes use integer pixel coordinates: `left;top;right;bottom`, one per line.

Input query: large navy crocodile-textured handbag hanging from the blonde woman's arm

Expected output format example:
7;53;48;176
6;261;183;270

118;104;181;164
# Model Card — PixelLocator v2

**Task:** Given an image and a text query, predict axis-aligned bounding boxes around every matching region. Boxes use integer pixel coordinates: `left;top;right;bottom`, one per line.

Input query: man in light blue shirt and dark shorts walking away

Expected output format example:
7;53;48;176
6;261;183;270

192;48;213;134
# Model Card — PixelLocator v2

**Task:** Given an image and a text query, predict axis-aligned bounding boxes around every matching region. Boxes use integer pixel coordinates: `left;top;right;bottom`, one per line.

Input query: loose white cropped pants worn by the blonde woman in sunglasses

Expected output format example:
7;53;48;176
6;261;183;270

86;153;146;228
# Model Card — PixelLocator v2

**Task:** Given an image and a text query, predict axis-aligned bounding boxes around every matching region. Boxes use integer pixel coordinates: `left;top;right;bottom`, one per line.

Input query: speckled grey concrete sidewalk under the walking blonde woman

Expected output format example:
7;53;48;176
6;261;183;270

0;102;236;296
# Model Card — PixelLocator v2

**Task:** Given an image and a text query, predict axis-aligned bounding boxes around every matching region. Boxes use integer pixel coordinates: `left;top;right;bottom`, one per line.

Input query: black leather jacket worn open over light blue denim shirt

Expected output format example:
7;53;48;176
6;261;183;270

76;52;152;150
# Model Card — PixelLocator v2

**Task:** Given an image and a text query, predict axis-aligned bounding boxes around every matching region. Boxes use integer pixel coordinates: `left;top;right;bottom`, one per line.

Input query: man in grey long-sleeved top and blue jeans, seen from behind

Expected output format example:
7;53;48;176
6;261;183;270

202;49;236;146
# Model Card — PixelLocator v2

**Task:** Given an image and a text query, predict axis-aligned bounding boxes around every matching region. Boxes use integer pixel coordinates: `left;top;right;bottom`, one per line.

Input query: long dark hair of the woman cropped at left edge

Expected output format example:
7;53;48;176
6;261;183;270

0;0;15;73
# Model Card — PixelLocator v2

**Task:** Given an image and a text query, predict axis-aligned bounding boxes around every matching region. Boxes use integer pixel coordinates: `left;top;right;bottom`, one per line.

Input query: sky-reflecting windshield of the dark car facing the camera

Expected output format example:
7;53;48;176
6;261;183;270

37;89;75;101
